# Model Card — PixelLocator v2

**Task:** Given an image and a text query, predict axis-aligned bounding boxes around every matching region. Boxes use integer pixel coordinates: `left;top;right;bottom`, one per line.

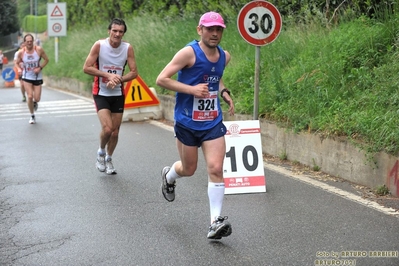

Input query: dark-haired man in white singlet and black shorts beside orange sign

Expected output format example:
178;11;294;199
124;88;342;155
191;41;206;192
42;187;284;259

83;18;137;175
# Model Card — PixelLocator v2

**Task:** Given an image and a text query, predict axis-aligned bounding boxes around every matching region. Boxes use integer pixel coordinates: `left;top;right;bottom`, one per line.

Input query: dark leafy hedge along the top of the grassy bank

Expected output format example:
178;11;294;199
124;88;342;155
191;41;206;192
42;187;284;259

65;0;394;27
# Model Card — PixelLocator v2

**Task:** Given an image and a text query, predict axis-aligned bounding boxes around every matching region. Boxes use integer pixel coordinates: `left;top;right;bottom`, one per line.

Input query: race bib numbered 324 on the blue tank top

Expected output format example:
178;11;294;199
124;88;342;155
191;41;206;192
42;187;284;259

192;91;219;121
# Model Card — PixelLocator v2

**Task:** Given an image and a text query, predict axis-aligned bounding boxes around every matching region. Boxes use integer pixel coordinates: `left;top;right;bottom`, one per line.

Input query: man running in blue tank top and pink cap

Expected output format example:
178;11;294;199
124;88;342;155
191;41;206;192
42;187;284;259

156;12;234;239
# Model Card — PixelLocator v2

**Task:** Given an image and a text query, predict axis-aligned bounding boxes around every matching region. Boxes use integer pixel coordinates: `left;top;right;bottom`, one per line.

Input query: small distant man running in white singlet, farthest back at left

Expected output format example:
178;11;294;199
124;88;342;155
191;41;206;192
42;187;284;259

15;34;48;124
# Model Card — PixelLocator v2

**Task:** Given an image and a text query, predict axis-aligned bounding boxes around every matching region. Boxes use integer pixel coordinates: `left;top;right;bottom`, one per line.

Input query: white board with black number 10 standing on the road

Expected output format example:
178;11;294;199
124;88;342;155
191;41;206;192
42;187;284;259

223;120;266;194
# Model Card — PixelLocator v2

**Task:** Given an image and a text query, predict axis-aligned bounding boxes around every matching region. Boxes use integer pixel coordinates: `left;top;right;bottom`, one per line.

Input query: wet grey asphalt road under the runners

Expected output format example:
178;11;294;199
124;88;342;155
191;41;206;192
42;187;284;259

0;84;399;266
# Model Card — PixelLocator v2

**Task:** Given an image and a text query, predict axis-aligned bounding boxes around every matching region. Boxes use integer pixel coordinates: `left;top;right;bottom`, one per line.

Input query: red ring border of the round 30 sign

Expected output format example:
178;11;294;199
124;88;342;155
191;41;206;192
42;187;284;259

237;1;281;46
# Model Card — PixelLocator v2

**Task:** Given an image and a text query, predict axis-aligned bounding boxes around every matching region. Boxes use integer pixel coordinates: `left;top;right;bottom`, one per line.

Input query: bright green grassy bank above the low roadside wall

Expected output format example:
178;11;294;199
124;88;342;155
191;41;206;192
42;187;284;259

37;2;399;158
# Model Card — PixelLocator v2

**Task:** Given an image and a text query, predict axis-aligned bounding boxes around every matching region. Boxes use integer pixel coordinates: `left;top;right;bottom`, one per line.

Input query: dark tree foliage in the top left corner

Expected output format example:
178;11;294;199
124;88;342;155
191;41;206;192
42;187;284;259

0;0;19;36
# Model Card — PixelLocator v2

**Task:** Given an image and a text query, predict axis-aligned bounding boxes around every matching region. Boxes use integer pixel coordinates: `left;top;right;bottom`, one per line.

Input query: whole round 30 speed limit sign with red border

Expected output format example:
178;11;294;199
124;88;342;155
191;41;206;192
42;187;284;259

237;1;281;46
